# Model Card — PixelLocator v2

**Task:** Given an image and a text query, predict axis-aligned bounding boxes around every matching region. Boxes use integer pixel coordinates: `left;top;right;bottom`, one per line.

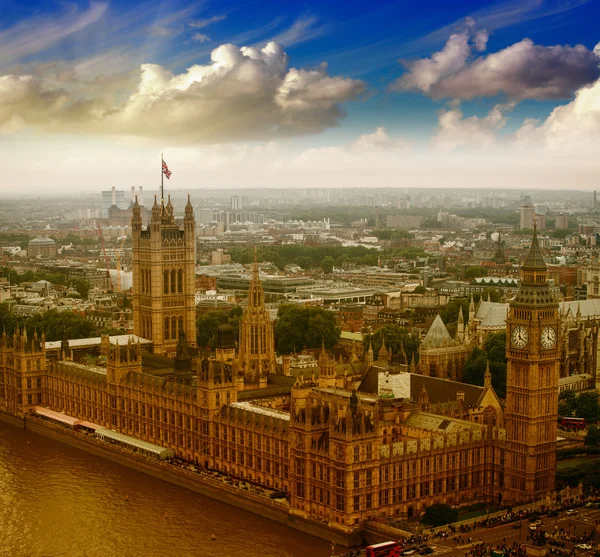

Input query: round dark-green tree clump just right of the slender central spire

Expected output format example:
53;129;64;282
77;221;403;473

275;304;341;354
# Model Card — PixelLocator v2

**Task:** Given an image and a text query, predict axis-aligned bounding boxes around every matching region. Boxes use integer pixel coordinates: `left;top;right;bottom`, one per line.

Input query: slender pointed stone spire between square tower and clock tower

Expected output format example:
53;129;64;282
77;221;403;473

238;252;275;384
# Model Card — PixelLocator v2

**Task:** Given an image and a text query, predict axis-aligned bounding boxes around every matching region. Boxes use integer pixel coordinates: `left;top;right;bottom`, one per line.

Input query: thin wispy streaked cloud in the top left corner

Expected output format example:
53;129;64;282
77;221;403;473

0;2;108;65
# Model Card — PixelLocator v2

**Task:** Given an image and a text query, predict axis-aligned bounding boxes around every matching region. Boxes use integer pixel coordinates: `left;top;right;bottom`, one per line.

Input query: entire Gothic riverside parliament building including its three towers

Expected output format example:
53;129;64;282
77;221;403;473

0;199;572;531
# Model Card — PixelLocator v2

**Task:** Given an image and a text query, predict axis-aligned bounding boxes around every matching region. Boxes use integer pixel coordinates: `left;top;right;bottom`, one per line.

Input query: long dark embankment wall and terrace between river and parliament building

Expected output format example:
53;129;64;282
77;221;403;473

0;411;363;547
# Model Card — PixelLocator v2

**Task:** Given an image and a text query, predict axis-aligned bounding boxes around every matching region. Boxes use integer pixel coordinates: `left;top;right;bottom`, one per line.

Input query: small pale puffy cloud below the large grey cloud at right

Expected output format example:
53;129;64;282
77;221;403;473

431;104;513;152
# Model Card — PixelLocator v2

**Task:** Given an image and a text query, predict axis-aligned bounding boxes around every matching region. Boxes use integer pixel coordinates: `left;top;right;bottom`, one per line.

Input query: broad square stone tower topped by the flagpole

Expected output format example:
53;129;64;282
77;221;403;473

131;195;196;354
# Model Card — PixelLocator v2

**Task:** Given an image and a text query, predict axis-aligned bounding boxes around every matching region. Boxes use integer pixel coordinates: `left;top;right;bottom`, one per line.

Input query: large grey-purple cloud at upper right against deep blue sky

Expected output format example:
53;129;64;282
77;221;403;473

391;25;600;100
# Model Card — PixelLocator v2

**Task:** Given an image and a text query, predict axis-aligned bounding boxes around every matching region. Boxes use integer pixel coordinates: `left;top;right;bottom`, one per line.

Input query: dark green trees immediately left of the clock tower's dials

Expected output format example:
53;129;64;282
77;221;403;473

462;331;506;398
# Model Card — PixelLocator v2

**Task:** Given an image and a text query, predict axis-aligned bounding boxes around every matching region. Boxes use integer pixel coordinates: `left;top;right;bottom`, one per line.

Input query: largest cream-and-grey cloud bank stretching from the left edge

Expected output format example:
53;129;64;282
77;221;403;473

0;42;365;143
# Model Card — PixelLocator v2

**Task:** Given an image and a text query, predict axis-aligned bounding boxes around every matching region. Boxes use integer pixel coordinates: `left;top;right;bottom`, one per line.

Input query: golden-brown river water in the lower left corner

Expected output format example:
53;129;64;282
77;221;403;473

0;422;328;557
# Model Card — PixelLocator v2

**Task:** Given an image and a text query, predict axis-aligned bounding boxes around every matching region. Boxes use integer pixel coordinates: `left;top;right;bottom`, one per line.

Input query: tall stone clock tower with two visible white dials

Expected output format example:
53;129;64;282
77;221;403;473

504;225;560;504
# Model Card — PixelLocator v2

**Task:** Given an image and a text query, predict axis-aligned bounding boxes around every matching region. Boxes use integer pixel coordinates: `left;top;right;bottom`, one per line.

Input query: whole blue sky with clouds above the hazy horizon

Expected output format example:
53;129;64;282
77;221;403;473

0;0;600;196
